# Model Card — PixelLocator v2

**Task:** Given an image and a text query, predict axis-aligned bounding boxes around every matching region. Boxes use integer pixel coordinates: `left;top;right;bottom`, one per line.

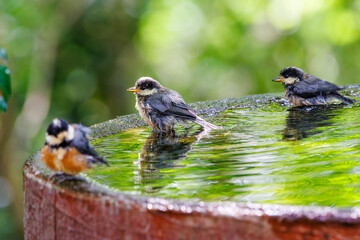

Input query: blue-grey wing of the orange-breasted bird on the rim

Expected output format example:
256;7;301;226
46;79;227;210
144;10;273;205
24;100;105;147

71;124;108;165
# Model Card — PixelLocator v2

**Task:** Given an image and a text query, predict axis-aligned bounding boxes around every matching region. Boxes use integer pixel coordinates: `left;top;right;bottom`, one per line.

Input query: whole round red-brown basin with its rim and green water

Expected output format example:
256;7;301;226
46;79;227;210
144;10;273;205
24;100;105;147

24;86;360;239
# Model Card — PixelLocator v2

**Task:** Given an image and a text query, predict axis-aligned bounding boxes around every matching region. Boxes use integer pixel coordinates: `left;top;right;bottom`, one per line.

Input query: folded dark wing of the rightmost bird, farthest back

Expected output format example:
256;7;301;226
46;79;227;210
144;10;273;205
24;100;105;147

293;75;339;98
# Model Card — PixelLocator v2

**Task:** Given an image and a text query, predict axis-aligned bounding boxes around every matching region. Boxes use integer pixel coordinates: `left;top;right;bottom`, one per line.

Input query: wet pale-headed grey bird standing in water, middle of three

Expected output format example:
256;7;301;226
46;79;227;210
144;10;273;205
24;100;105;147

128;77;221;133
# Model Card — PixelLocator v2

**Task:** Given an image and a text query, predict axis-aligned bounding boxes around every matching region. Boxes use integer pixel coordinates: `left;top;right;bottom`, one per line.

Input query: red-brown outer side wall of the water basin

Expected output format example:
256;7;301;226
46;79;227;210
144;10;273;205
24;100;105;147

24;173;360;240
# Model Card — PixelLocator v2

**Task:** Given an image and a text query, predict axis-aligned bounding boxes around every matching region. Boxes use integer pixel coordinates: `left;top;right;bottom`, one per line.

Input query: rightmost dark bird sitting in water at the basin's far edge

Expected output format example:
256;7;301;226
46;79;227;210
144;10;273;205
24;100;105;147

273;67;355;107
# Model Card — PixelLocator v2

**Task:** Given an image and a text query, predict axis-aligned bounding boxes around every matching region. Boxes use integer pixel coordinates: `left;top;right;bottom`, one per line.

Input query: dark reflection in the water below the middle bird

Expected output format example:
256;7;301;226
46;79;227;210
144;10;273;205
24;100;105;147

135;129;207;193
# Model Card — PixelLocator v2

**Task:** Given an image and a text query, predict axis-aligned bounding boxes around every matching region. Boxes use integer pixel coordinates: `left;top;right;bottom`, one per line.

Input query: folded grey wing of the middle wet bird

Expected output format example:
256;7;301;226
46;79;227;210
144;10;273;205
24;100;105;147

144;89;197;120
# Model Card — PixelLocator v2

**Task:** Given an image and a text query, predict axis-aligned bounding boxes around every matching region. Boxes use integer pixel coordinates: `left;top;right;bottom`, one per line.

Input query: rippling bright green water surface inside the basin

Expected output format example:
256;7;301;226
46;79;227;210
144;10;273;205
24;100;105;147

86;105;360;206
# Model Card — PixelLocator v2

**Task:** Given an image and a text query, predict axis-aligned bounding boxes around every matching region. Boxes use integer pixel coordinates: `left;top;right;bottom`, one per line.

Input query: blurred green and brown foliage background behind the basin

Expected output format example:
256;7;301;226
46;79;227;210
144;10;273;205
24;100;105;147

0;0;360;239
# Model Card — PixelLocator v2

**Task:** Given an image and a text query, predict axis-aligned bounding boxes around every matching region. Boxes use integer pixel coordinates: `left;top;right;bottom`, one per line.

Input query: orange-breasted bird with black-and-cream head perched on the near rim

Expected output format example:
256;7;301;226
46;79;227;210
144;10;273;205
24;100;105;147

41;118;109;175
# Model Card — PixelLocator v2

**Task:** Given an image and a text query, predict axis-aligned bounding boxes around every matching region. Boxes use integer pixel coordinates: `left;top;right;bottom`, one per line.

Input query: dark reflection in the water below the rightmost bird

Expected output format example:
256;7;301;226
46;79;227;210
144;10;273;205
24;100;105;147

283;106;337;141
